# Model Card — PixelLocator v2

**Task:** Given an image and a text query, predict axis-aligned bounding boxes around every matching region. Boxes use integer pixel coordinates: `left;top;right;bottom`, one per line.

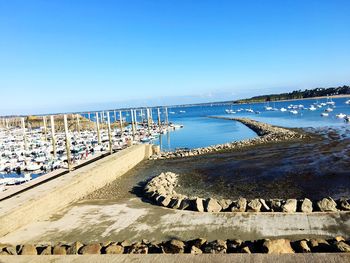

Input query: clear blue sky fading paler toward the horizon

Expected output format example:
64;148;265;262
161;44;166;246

0;0;350;114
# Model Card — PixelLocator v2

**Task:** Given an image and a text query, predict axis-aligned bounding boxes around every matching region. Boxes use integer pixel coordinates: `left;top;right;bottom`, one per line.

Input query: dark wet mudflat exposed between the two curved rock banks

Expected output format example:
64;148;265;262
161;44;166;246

86;127;350;202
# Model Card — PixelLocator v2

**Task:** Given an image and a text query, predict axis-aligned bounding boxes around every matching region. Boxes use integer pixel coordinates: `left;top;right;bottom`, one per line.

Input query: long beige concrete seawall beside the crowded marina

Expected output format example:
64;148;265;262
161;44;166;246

0;144;152;236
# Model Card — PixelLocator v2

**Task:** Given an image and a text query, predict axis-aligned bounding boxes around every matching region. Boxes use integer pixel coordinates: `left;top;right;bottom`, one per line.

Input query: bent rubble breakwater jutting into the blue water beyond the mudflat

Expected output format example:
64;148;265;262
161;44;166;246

150;117;309;160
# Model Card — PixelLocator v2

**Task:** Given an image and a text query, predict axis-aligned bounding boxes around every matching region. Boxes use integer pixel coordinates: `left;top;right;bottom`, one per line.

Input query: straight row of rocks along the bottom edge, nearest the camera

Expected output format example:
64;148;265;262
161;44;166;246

0;236;350;256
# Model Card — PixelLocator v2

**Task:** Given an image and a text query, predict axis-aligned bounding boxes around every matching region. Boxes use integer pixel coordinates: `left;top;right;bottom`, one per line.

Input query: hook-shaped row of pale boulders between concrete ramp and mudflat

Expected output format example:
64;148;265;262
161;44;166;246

144;172;350;213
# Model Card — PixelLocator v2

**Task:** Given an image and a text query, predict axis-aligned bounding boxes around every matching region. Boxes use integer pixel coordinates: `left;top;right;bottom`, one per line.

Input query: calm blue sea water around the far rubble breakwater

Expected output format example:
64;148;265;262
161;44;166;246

158;98;350;151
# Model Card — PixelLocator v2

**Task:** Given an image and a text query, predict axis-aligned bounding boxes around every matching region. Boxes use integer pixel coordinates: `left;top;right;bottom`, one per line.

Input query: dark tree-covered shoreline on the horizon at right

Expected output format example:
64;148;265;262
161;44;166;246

234;85;350;103
